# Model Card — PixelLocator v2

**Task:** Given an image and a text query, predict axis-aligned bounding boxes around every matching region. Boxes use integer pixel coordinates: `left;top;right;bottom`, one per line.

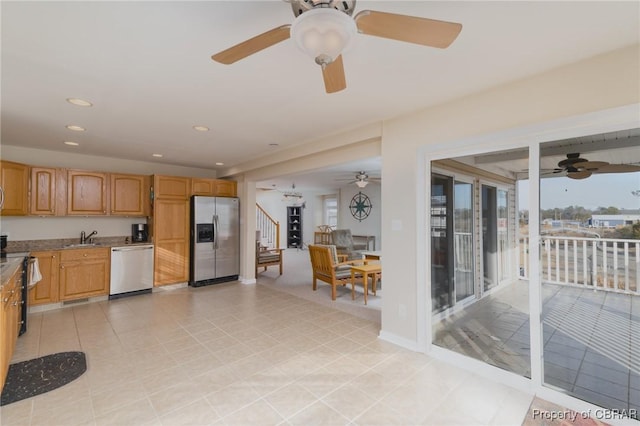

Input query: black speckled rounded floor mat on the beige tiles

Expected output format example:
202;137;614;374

0;352;87;405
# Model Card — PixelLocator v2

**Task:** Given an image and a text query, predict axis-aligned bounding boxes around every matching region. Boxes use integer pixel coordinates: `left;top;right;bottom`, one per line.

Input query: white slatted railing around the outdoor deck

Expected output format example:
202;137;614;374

519;236;640;294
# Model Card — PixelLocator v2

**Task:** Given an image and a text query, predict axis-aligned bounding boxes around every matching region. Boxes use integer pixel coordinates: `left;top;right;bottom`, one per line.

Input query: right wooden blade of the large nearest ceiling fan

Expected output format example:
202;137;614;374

354;10;462;49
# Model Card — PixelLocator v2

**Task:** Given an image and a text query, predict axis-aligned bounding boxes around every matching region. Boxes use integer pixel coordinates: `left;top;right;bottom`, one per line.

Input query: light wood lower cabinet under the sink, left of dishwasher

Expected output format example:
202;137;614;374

58;247;111;301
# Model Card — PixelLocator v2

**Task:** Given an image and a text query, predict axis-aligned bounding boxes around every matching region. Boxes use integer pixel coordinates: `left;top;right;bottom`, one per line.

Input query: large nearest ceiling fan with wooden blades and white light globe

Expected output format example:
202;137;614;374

211;0;462;93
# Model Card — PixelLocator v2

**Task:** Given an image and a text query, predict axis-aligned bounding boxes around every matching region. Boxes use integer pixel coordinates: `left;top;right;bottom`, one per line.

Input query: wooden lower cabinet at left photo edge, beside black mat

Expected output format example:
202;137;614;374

0;268;22;389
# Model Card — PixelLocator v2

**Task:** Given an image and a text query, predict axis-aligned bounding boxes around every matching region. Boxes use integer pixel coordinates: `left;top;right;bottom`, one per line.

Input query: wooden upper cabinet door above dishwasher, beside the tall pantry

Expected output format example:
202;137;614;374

110;173;149;216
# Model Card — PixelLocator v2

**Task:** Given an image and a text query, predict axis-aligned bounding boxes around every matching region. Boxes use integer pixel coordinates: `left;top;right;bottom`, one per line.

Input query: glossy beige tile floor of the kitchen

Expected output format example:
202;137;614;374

0;283;532;426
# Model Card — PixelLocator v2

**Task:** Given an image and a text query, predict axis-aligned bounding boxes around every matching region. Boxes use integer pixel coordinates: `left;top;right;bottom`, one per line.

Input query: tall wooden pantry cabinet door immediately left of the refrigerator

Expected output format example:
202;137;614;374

153;199;189;286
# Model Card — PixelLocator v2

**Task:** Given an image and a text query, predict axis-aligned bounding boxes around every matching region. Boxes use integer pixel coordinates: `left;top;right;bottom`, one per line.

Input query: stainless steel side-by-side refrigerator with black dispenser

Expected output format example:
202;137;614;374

189;196;240;287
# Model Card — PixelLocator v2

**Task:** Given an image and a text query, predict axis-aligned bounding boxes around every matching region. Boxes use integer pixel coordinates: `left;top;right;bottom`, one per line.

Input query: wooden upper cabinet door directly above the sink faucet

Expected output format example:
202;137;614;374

67;170;108;216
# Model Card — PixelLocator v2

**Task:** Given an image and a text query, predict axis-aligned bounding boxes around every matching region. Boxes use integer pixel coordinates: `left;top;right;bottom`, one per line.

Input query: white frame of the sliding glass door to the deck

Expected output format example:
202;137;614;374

416;103;640;410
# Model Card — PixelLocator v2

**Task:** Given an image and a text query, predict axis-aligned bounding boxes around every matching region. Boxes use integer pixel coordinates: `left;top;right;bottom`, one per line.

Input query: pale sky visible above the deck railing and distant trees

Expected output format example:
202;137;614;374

518;172;640;210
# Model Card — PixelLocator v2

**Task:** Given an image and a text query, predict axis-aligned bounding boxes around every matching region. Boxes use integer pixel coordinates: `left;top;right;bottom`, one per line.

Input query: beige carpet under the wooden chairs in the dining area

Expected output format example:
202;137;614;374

257;249;383;324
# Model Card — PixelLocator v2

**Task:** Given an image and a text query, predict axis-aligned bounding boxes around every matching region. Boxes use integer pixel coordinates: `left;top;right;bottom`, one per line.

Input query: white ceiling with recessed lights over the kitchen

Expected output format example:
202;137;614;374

1;1;640;190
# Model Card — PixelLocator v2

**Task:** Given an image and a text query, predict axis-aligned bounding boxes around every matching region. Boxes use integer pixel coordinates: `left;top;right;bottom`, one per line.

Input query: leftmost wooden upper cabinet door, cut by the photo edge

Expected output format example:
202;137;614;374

0;161;29;216
